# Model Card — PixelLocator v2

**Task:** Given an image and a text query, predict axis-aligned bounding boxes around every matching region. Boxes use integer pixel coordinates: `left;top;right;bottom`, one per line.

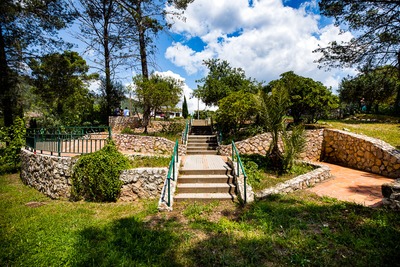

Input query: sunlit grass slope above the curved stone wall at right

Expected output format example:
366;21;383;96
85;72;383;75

319;115;400;149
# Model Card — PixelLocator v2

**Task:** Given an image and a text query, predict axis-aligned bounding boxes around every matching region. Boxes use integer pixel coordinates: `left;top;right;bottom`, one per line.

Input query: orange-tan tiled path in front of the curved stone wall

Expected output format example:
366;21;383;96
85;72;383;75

307;162;393;207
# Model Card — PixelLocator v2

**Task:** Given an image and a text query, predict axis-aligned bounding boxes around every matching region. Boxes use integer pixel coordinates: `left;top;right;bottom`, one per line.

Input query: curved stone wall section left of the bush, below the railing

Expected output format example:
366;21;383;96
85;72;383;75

20;149;77;199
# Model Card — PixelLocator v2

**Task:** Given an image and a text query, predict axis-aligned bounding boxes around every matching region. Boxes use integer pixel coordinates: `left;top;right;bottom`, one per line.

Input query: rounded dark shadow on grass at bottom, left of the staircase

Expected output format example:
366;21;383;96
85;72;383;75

73;217;180;266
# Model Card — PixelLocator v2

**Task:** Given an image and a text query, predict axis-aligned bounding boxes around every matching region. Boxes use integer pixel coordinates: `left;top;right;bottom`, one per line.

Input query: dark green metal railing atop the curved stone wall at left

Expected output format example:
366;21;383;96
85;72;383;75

25;126;111;156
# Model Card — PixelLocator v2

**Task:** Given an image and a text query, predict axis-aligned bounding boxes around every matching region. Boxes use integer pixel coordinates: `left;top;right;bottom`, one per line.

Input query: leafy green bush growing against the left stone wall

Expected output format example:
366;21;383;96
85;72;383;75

71;141;130;202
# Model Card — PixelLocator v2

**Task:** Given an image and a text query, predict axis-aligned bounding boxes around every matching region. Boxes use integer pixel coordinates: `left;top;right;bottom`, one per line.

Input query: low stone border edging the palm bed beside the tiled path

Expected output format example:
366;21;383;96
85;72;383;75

255;163;331;199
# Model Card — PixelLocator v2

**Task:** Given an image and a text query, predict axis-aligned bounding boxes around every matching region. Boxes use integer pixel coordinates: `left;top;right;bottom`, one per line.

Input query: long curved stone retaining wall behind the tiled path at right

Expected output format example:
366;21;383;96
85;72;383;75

322;129;400;178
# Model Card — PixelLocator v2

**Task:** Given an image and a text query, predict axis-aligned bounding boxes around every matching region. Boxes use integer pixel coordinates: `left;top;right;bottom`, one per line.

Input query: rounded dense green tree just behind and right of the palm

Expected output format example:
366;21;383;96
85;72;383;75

266;71;338;124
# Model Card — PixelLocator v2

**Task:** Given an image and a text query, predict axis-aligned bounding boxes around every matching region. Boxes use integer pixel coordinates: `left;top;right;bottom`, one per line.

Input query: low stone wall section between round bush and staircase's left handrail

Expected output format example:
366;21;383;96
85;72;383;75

119;168;168;201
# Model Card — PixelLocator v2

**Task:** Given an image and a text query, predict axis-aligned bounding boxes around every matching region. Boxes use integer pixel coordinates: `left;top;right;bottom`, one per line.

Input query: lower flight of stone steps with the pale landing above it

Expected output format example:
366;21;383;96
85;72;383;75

174;155;236;202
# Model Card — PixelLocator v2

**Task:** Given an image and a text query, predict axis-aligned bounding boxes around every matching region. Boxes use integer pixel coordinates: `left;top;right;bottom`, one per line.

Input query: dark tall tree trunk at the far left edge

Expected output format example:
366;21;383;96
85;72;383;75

0;25;14;127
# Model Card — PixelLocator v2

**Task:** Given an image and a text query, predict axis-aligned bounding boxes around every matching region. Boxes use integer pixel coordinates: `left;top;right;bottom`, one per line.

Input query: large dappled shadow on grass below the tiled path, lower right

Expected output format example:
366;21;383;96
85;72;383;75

188;196;400;266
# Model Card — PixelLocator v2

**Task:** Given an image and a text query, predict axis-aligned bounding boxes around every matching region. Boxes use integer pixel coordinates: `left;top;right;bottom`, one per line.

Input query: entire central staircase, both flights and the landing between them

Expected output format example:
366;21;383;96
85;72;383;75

174;120;236;202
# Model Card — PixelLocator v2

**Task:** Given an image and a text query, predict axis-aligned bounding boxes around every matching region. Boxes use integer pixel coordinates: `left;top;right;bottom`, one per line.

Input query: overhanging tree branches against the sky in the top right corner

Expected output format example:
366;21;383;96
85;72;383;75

315;0;400;115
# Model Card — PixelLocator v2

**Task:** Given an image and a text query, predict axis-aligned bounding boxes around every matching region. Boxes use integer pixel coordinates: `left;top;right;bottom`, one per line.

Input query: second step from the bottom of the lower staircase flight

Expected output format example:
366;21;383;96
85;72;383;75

178;183;236;194
